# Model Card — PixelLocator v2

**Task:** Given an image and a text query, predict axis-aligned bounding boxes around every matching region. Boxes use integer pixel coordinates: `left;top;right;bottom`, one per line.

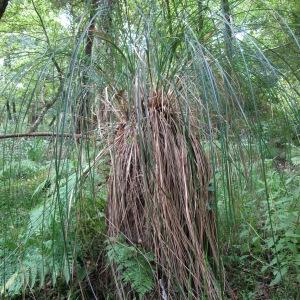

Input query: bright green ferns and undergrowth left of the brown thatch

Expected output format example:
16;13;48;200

0;141;106;297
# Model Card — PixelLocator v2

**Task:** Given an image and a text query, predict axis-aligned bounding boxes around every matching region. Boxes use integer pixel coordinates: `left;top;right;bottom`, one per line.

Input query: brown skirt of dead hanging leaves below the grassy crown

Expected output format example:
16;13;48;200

108;88;219;299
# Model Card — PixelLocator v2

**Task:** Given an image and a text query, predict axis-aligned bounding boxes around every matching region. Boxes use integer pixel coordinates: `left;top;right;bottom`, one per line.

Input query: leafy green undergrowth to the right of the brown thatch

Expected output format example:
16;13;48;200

219;151;300;299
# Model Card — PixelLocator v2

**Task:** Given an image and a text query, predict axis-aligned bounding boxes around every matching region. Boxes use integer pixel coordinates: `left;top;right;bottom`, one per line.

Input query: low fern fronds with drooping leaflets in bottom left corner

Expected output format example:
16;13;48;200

0;235;73;296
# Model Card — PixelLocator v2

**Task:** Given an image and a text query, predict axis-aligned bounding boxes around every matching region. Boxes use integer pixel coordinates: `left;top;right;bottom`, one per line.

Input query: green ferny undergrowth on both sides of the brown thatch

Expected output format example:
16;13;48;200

0;138;300;299
